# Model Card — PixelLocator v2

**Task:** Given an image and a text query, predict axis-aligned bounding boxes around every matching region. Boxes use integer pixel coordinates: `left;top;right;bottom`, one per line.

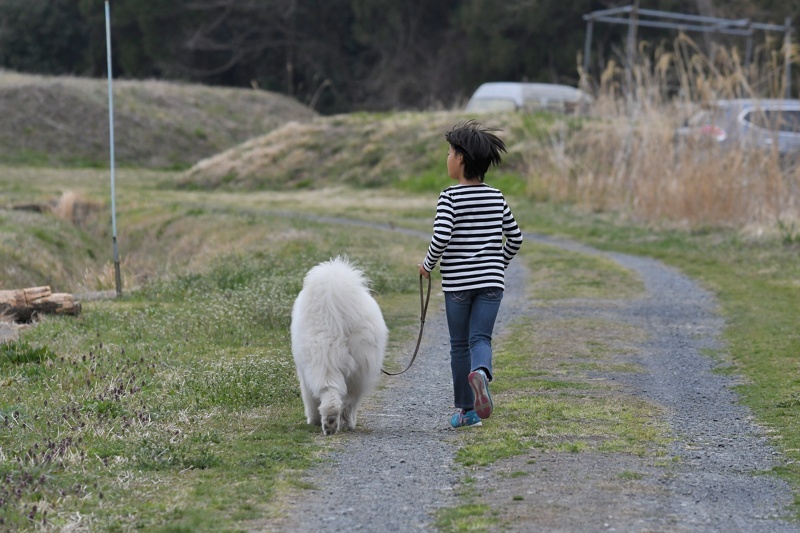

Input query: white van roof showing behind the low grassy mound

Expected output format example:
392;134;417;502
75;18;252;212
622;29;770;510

465;82;591;113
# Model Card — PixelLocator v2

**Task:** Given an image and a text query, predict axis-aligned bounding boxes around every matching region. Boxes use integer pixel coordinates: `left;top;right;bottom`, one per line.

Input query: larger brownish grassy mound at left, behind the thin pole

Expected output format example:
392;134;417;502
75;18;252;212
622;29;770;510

0;71;316;168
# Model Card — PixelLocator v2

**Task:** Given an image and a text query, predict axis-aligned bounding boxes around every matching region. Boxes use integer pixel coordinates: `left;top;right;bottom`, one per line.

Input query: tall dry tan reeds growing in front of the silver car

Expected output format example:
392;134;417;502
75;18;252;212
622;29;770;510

528;35;800;227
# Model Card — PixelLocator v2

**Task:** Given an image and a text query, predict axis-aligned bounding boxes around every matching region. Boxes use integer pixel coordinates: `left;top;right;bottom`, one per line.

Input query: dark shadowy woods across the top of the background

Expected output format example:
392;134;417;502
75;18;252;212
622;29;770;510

0;0;800;113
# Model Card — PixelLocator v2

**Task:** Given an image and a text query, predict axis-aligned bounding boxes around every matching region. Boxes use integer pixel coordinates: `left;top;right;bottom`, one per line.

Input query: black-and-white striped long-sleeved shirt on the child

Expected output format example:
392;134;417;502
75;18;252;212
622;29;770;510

423;184;522;292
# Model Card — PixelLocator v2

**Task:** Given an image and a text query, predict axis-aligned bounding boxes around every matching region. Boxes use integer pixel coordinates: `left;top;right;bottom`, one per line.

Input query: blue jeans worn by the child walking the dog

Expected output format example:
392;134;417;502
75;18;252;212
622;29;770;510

444;287;503;410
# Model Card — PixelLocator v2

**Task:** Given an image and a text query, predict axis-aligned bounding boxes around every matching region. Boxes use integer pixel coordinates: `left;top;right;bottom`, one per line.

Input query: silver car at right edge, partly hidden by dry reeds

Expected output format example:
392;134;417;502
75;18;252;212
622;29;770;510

675;99;800;156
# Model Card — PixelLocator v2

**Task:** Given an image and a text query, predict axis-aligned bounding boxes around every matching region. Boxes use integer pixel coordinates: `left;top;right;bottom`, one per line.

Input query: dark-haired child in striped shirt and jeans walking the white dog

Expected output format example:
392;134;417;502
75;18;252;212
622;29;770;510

419;120;522;428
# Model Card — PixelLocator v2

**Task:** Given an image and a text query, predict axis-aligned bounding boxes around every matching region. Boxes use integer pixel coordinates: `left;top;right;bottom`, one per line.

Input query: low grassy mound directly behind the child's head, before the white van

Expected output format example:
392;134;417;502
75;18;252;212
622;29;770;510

179;112;530;190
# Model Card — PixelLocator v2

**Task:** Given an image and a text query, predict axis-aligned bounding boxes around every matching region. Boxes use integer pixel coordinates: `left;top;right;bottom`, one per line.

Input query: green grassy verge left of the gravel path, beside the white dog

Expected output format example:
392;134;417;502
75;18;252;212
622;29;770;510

0;203;424;531
